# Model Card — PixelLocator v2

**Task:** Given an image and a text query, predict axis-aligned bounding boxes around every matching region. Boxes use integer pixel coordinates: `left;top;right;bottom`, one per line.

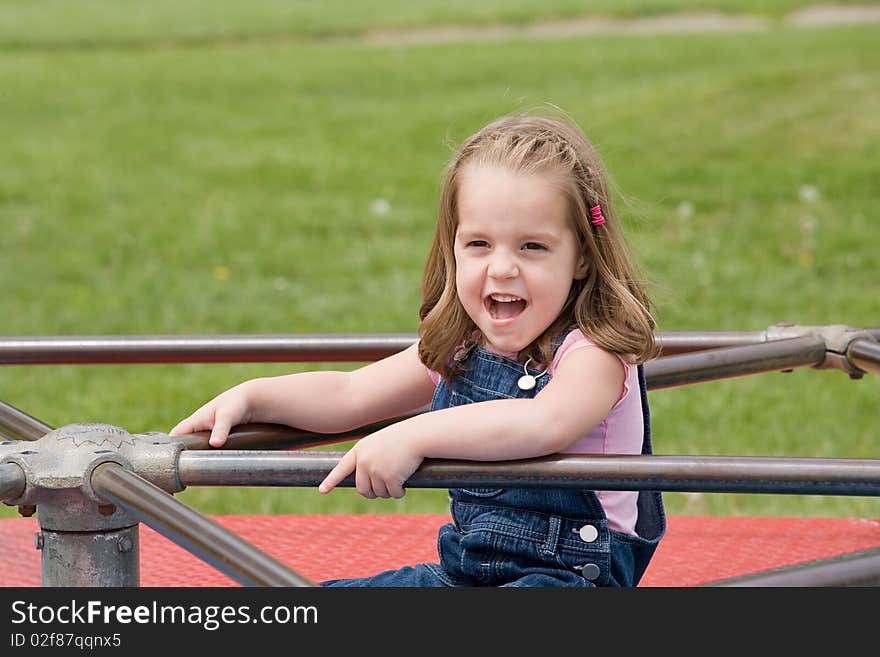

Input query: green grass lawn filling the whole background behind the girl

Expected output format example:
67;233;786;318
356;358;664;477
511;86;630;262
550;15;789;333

0;0;880;517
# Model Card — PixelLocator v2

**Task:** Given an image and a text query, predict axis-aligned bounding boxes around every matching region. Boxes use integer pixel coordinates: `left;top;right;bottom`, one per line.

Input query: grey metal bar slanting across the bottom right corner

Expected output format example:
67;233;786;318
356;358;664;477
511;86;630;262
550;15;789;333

700;548;880;587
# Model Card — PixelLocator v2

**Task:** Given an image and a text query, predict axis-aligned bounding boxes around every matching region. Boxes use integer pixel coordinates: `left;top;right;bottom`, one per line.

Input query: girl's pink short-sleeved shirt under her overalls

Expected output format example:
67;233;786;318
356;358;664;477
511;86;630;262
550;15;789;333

427;329;644;534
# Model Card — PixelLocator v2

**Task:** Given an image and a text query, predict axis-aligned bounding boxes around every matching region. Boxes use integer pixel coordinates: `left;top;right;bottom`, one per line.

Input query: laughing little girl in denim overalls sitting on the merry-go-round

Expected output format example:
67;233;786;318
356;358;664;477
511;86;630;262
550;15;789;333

171;111;665;586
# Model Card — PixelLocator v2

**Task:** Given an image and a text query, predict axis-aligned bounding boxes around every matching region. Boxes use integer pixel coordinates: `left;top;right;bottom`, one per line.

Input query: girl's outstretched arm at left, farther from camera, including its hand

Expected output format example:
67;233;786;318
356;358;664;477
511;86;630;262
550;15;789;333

170;344;434;447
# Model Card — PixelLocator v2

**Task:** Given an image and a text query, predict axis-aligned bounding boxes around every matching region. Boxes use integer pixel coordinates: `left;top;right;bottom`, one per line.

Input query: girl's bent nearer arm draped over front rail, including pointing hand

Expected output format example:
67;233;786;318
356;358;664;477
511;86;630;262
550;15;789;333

319;347;624;497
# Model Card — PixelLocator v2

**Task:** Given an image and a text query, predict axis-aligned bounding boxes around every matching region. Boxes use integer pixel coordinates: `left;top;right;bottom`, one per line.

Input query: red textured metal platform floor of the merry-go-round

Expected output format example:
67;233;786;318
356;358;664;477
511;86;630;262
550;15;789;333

0;514;880;587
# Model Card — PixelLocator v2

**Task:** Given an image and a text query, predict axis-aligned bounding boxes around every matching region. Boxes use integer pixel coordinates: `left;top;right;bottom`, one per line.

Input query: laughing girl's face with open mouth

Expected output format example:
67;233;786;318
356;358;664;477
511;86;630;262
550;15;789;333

454;165;587;352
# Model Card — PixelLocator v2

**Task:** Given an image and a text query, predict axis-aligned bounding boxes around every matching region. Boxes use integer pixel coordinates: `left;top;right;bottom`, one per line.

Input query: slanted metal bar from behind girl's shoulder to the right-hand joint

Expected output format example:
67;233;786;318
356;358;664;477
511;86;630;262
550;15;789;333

645;335;825;389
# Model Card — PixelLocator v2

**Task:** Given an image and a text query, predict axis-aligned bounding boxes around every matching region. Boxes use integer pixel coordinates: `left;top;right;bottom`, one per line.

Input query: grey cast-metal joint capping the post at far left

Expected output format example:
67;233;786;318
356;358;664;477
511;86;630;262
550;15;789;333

0;422;184;532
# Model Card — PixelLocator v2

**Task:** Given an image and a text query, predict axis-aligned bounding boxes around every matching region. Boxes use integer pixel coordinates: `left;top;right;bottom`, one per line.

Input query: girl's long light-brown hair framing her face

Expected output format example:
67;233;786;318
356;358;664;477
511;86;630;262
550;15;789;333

418;115;657;379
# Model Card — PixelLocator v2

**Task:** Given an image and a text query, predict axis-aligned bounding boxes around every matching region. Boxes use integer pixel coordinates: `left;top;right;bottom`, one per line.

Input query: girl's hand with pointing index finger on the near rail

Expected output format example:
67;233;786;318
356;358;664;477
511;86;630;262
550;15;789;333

318;433;424;499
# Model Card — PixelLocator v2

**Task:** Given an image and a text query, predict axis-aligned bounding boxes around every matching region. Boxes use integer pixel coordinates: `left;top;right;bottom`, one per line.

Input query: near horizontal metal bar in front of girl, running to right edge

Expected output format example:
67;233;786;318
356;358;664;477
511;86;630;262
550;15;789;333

178;450;880;496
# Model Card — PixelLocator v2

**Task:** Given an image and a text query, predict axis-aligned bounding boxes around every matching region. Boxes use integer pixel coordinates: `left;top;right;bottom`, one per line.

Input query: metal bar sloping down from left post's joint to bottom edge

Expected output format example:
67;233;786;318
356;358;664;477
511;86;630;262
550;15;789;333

91;463;314;586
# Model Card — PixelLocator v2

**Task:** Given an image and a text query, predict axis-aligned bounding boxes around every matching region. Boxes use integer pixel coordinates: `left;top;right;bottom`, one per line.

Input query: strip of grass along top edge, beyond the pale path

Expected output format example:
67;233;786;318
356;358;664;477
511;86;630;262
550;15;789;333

0;0;870;44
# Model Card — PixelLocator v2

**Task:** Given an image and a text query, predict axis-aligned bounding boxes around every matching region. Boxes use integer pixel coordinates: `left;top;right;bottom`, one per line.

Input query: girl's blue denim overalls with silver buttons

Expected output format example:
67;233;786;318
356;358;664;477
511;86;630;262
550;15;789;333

322;340;666;587
